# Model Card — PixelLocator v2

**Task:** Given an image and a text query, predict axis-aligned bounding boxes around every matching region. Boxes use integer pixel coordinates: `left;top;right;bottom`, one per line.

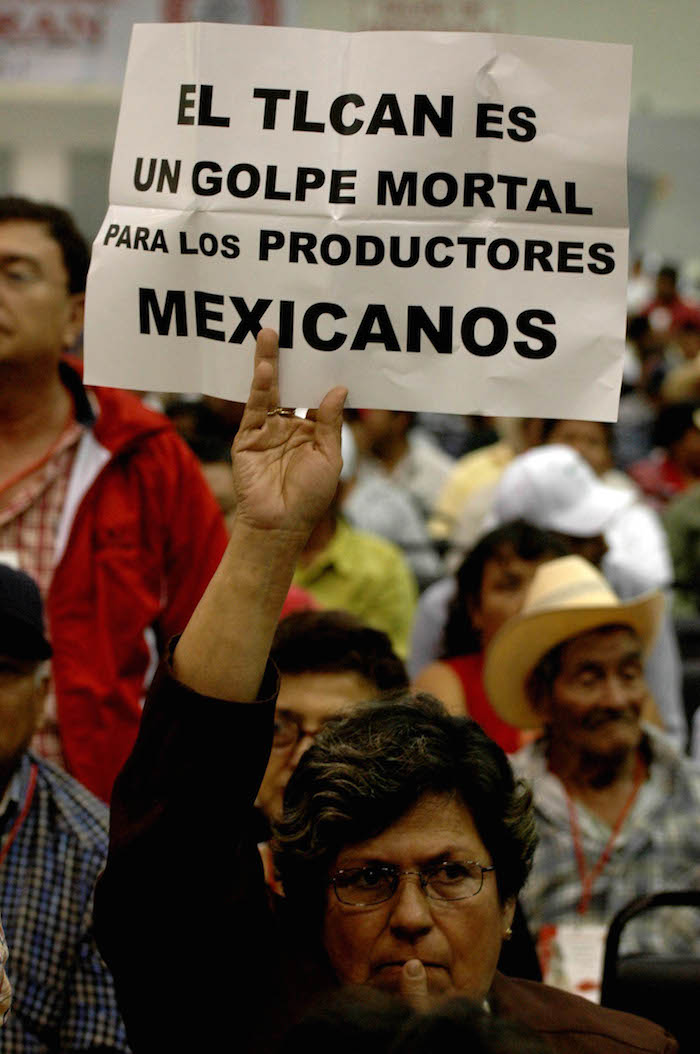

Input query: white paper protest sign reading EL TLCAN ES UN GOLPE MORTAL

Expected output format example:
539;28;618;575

85;24;631;421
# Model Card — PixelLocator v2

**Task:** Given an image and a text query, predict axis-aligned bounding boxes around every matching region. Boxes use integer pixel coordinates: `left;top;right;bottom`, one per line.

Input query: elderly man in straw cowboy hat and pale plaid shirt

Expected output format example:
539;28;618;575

484;557;700;999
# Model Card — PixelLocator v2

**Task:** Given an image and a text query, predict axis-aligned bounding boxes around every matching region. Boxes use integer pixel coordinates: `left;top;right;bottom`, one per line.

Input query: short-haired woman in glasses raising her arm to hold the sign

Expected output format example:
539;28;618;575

95;330;676;1054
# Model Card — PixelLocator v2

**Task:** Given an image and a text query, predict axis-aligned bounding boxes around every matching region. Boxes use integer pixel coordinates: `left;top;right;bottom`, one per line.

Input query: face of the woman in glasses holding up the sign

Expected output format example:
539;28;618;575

324;794;513;1000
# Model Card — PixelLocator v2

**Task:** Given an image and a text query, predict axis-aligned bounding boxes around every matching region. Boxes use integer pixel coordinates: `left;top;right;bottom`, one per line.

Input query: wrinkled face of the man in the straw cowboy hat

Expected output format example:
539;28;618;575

543;627;648;758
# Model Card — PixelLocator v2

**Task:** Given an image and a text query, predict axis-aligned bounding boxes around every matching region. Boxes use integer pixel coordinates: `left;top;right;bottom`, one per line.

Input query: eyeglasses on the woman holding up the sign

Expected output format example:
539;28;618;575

329;860;495;907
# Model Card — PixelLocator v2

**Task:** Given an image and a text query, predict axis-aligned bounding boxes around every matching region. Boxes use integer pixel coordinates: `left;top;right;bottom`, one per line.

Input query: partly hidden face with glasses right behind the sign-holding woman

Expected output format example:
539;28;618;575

255;670;380;820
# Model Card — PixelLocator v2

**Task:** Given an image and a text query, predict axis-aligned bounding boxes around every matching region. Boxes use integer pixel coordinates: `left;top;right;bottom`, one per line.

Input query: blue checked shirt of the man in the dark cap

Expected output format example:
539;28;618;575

0;752;129;1054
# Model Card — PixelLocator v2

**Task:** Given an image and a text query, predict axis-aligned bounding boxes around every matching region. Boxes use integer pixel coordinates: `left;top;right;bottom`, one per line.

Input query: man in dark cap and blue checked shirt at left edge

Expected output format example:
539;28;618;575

0;564;129;1054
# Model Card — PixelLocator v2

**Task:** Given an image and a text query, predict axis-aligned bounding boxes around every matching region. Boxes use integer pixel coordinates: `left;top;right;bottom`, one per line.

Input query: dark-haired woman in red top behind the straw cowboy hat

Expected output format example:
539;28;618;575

413;520;566;753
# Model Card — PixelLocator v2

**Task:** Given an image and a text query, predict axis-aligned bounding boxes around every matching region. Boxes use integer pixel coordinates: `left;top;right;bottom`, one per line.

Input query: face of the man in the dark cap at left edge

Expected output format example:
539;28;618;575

0;655;46;776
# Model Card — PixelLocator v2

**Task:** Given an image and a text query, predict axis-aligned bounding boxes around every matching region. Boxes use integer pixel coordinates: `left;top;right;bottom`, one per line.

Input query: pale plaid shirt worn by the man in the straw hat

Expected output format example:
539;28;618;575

510;726;700;955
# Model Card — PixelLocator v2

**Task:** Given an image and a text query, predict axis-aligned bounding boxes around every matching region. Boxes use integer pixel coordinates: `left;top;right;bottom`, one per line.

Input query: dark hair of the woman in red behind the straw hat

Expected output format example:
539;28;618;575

442;520;568;659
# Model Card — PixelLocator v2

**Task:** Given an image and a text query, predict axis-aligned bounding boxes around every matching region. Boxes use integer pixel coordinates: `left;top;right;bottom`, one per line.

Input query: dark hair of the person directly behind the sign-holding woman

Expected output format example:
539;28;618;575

270;611;408;692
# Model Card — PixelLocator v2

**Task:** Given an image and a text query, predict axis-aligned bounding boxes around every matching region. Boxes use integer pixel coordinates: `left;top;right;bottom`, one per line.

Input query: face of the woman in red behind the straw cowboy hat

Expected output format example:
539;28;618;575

469;546;546;650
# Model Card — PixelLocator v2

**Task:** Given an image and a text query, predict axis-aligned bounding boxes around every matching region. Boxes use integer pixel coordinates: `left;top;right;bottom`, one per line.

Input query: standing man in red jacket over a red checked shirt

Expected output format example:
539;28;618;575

0;198;227;799
